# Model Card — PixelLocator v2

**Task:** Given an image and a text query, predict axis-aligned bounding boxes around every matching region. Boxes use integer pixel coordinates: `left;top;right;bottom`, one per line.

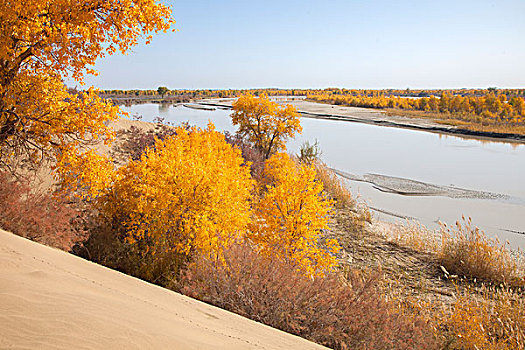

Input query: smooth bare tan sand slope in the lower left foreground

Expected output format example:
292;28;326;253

0;230;322;349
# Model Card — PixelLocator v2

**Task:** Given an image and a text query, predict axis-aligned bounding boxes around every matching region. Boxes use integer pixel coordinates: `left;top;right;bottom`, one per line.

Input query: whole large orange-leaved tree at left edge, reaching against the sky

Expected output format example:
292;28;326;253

0;0;174;171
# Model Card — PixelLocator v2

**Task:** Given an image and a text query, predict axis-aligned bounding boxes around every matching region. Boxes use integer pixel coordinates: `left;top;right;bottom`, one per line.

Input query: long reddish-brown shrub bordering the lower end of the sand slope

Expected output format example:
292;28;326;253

181;244;438;349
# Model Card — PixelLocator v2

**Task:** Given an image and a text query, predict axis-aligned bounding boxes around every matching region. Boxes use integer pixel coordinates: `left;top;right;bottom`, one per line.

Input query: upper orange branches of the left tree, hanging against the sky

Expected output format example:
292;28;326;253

0;0;175;81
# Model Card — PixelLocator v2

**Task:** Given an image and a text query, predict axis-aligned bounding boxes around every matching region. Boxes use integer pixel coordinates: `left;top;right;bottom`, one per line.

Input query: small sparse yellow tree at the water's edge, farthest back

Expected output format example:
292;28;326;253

231;94;303;159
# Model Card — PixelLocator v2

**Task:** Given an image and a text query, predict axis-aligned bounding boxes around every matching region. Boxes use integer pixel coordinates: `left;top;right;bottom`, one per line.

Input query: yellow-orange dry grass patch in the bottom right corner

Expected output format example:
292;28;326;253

384;284;525;350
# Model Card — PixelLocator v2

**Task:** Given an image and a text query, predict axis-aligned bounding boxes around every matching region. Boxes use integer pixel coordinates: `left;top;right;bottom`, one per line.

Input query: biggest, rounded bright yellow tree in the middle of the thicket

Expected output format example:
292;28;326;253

97;124;253;262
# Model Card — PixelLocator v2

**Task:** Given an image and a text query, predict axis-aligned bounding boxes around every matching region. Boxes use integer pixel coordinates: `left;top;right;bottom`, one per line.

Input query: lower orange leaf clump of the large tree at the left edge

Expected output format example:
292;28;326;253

0;71;118;165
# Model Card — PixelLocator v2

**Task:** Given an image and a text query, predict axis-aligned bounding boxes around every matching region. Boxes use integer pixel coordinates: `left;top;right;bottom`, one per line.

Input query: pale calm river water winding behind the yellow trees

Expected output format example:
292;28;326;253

122;104;525;250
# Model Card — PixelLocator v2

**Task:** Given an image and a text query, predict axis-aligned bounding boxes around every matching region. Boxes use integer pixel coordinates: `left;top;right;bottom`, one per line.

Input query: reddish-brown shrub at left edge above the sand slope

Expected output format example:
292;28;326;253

0;172;83;251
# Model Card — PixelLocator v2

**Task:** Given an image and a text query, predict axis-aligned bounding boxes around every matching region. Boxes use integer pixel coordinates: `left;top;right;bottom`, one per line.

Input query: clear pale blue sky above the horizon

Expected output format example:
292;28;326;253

77;0;525;89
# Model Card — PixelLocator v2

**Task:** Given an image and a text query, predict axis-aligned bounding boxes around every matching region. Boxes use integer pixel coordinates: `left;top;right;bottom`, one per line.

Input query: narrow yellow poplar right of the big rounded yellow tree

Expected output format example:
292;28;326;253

248;153;340;276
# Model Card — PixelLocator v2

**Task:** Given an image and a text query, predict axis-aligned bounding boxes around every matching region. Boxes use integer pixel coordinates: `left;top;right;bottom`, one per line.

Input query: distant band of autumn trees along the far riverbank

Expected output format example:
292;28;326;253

100;87;525;134
